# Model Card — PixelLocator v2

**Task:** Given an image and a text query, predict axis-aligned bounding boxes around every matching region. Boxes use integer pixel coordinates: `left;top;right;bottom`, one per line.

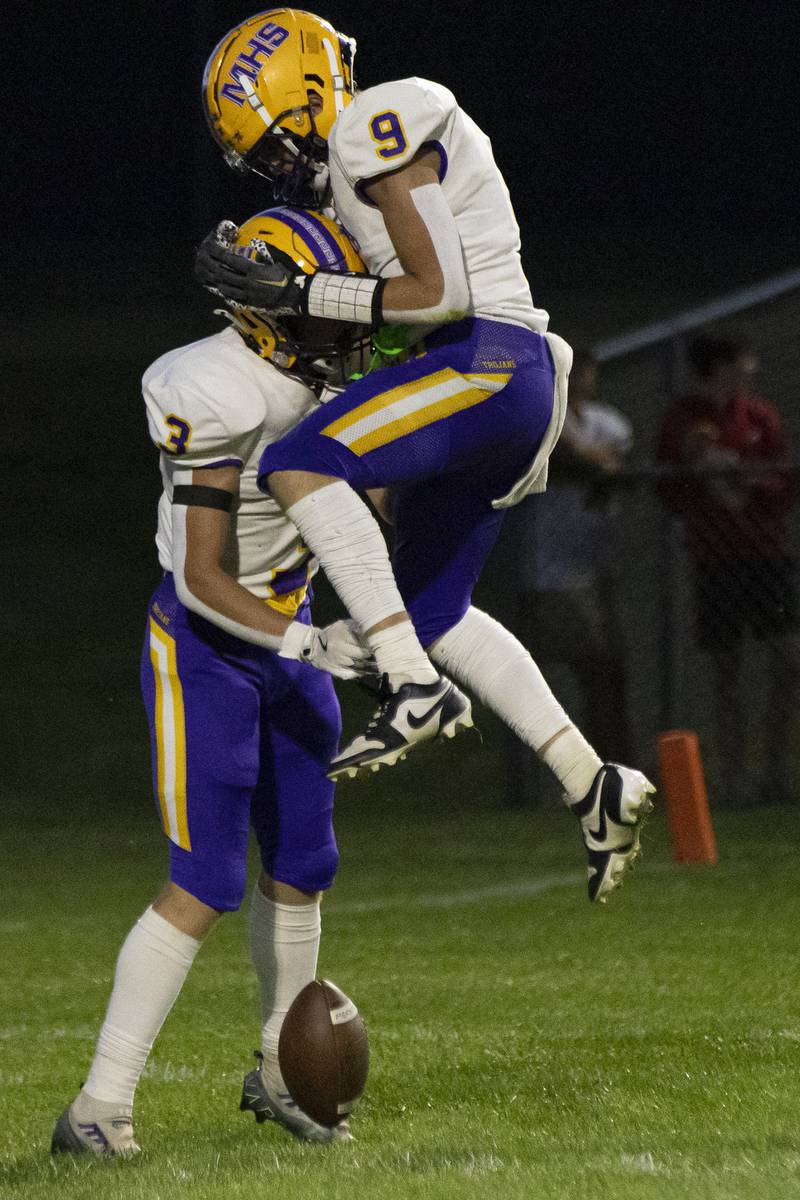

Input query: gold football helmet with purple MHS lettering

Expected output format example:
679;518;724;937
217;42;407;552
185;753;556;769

203;8;355;208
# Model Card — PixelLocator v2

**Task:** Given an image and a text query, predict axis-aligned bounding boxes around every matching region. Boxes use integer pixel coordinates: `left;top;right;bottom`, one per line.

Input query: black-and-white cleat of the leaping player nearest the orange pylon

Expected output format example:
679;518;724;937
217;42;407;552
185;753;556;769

570;762;655;904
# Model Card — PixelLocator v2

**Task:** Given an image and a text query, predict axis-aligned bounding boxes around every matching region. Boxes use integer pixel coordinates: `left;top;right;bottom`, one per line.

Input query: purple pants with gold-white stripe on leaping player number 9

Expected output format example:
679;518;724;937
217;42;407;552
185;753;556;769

259;318;554;646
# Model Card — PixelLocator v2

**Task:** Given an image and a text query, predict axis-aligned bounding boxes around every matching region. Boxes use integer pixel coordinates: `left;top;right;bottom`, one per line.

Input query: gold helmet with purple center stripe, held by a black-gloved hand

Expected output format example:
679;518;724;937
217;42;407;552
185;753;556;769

222;205;369;390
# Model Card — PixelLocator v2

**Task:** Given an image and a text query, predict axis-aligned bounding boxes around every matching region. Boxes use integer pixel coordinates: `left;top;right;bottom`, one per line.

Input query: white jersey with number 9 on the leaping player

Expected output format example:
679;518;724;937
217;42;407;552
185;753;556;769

329;79;548;334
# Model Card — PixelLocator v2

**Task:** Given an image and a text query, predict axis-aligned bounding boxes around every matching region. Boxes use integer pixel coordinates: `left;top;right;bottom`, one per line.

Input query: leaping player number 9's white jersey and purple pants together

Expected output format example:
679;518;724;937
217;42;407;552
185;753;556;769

259;79;571;646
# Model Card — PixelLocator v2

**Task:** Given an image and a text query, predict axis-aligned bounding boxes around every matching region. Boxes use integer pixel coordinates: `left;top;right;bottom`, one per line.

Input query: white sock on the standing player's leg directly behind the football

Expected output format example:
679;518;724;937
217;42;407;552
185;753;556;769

249;883;321;1092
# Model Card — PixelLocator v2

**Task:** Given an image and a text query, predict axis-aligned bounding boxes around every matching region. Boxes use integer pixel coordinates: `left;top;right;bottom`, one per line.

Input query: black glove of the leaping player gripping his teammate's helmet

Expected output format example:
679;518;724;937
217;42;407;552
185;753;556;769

194;221;306;317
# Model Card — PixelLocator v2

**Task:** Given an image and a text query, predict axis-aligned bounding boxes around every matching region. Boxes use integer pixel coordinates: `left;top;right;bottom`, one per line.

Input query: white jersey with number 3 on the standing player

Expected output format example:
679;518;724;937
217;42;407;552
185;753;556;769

142;329;318;616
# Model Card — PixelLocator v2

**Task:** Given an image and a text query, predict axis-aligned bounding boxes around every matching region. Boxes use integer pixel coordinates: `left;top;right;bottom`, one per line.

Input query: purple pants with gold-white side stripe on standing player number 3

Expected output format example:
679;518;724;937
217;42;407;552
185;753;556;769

142;574;341;911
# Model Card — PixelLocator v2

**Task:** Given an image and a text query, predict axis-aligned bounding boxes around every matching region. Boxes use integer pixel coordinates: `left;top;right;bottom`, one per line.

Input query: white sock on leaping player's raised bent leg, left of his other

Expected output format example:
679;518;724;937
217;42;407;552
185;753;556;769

287;481;437;686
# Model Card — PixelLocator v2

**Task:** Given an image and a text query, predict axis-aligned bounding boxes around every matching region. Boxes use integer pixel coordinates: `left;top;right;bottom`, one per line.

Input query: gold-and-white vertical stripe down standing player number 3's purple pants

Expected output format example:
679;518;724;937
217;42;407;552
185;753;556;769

150;617;192;850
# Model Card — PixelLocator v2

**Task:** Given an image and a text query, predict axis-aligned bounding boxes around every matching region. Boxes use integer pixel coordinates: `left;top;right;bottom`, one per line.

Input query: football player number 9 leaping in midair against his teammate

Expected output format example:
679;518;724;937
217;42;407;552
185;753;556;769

197;8;654;900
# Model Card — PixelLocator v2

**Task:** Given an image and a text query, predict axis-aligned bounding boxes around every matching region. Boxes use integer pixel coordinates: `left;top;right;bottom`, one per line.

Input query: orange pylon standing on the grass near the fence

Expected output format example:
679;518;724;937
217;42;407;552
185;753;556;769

658;730;717;863
